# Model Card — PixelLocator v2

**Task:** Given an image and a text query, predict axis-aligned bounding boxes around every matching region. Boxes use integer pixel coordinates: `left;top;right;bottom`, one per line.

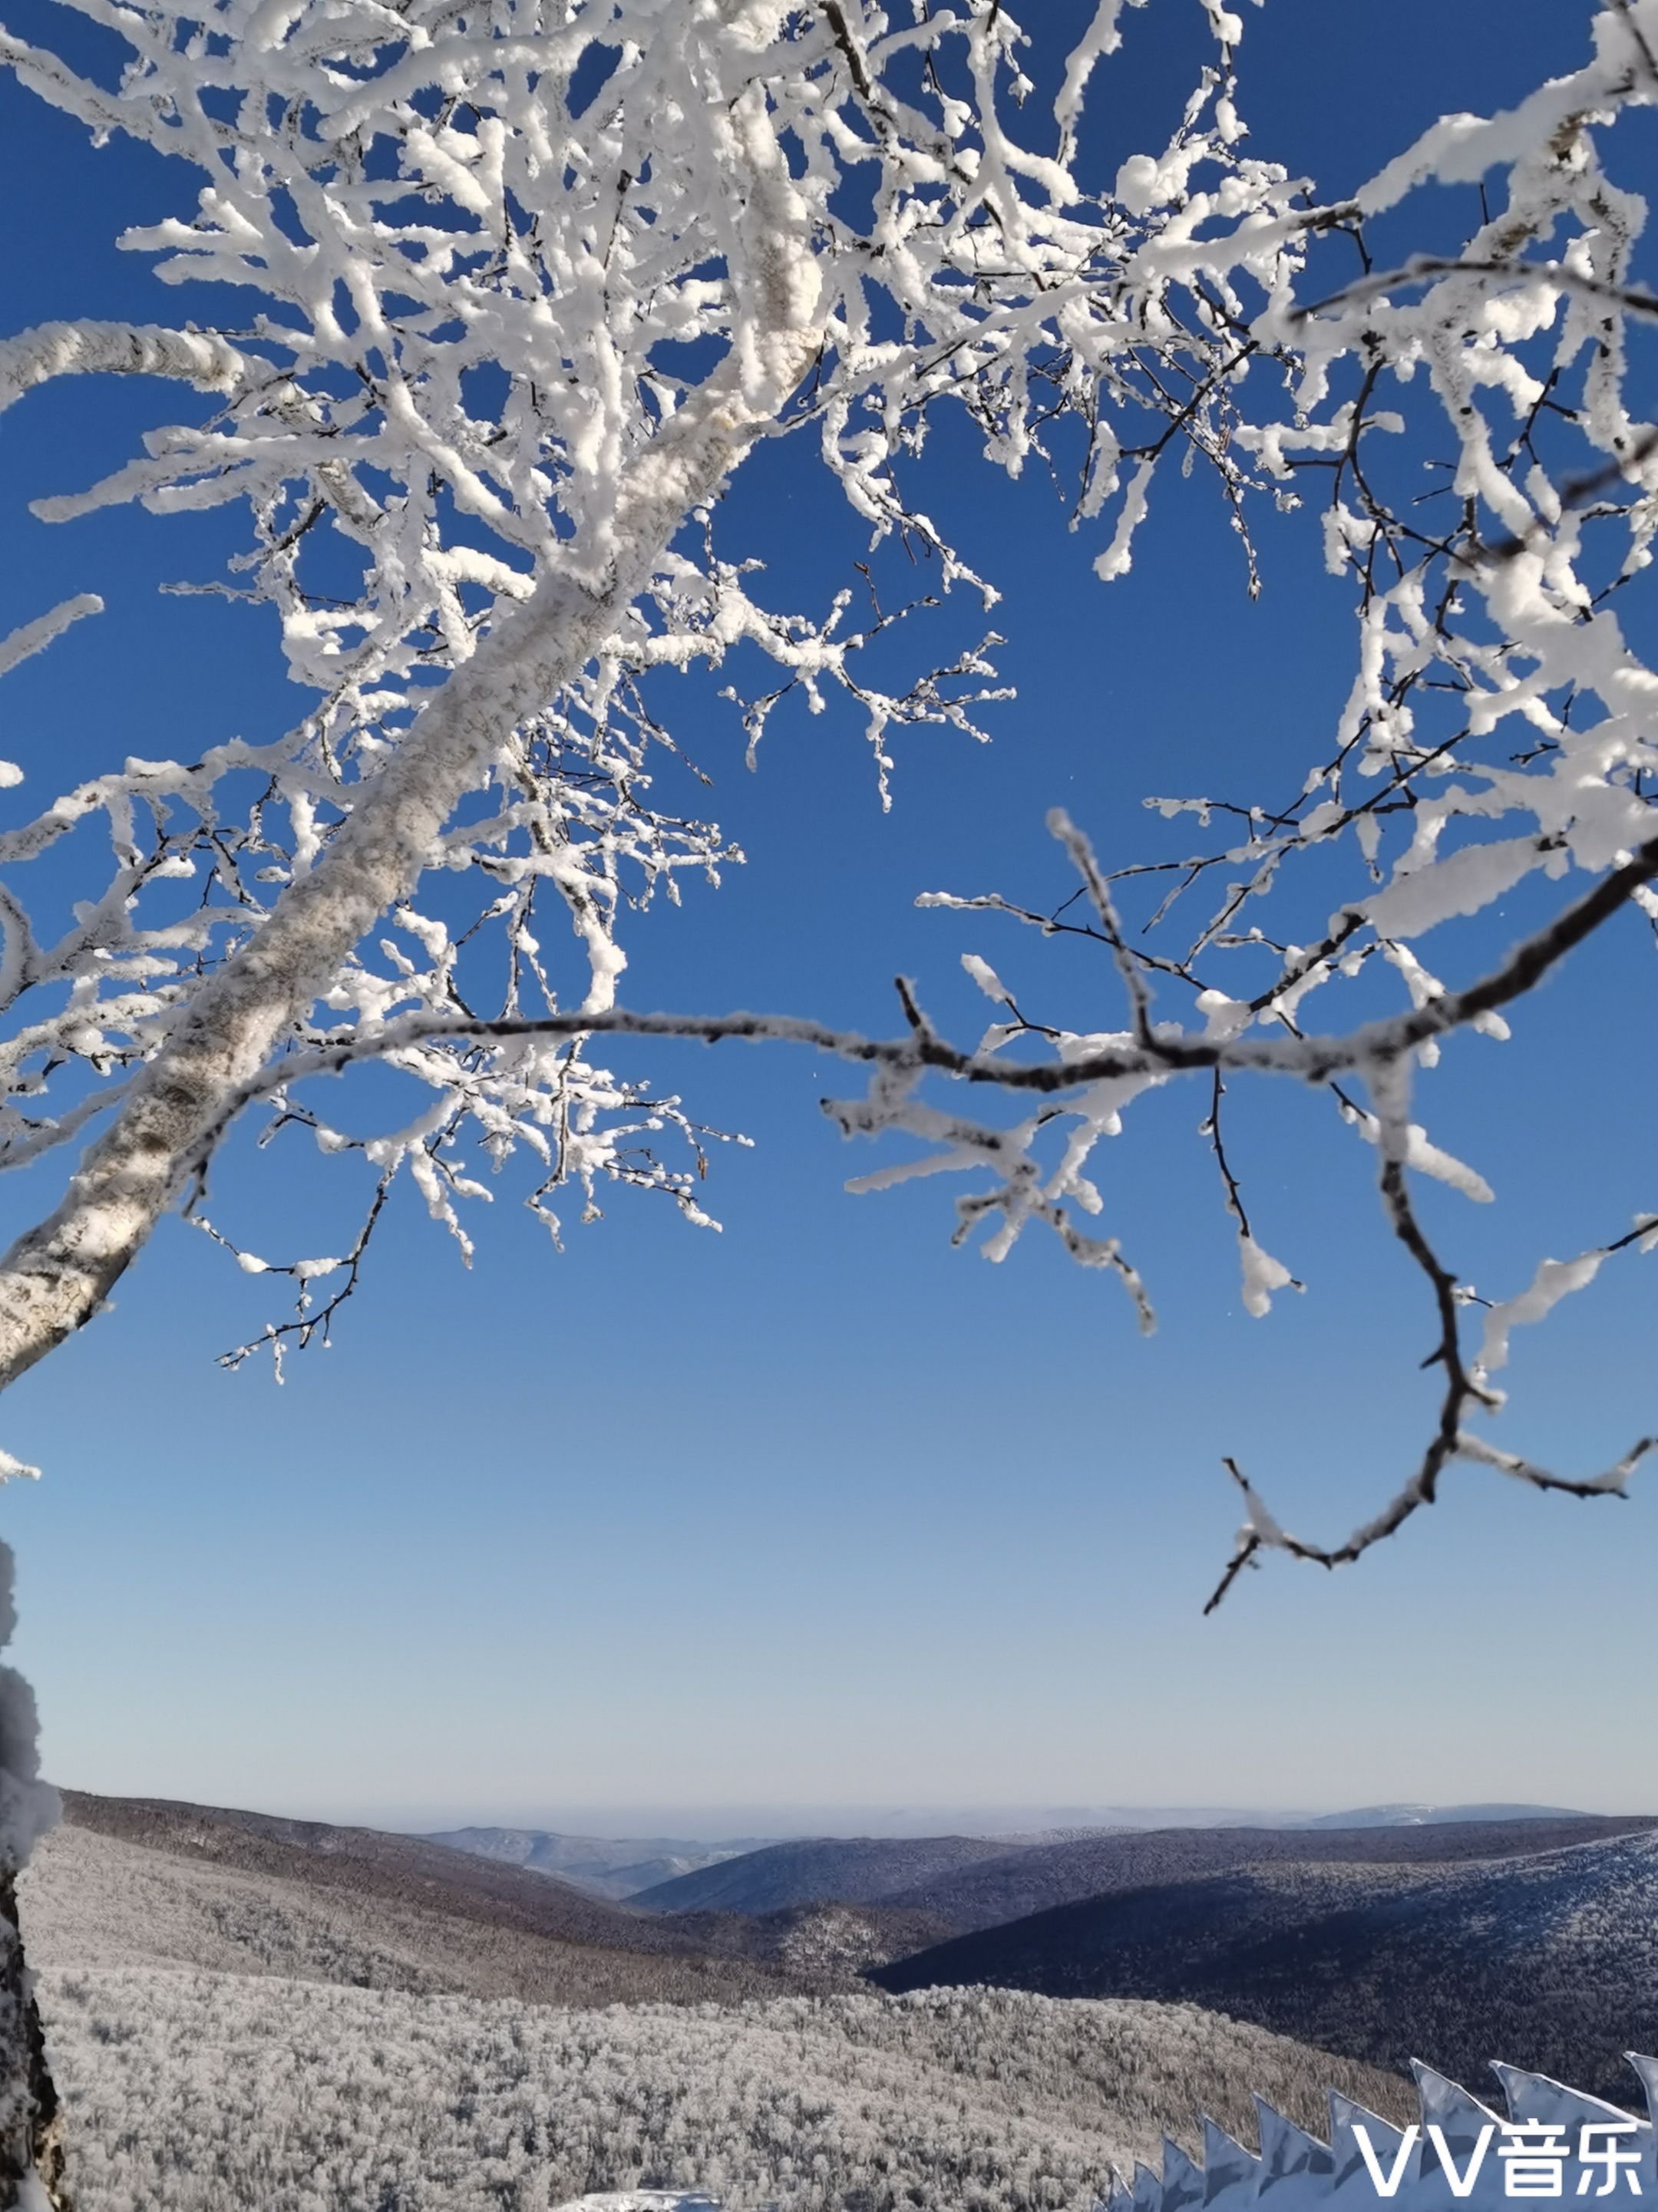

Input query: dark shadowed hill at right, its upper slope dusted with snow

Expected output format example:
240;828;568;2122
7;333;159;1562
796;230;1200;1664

870;1821;1658;2097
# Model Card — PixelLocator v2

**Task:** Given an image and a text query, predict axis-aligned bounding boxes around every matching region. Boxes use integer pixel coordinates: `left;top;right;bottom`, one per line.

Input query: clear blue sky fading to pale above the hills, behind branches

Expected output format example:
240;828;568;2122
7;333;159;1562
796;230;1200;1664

0;0;1658;1827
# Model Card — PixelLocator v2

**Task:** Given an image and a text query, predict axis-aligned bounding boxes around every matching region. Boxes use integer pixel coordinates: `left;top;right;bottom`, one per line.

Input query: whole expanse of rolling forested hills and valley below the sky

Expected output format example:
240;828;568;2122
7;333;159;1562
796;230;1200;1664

20;1791;1658;2212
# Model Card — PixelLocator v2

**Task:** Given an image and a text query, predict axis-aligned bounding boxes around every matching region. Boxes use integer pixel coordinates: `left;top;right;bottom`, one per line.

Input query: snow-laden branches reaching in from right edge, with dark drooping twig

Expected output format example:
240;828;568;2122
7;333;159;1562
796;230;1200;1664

814;0;1658;1603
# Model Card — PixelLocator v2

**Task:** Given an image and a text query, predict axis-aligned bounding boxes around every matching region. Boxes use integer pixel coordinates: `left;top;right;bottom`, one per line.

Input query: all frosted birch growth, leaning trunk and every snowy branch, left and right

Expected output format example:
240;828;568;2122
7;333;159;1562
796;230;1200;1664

0;0;1658;2201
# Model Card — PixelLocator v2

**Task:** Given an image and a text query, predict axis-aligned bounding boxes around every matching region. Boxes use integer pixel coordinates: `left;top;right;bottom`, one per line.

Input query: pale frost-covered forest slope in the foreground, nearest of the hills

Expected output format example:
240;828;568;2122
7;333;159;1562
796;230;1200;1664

42;1969;1410;2212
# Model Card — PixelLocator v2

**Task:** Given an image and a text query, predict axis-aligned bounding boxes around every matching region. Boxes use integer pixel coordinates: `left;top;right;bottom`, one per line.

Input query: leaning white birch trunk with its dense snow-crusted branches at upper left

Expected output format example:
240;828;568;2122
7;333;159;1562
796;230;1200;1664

0;0;1302;1374
